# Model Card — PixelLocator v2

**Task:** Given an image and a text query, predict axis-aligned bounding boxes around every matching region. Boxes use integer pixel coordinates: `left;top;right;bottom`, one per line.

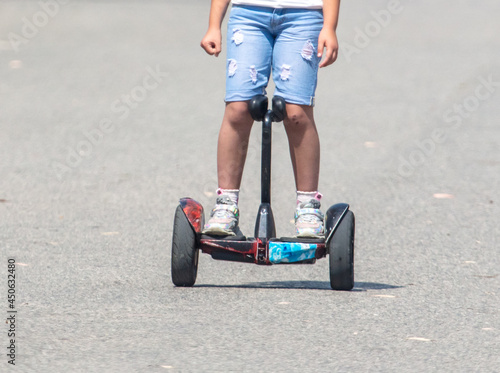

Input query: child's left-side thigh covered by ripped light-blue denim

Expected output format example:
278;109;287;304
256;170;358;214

225;7;273;102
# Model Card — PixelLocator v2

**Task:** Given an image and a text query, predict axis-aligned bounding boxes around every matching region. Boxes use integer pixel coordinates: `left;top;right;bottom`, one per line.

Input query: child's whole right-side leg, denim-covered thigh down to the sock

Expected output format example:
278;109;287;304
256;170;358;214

273;9;323;191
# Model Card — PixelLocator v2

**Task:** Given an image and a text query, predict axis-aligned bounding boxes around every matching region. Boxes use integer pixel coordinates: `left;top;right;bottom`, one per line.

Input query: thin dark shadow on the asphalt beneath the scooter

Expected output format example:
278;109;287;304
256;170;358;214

194;281;404;292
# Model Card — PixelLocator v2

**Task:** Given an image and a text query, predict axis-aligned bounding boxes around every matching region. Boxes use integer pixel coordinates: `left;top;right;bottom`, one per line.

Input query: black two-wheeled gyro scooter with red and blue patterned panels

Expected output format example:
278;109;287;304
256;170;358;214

171;95;354;290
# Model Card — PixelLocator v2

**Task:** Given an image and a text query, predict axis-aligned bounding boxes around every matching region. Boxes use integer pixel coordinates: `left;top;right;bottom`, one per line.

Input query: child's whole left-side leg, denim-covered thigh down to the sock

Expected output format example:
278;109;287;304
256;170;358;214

217;6;273;189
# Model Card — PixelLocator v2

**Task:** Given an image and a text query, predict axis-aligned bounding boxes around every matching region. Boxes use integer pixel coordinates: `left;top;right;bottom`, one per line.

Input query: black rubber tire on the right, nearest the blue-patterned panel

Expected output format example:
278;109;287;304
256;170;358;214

329;211;355;290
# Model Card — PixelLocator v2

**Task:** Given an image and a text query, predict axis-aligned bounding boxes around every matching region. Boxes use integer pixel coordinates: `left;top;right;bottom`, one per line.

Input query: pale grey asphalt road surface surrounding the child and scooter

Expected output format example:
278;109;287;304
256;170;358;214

0;0;500;372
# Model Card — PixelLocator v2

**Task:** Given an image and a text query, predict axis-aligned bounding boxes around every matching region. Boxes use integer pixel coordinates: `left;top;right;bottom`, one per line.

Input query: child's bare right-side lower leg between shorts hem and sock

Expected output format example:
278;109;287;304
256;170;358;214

284;104;320;192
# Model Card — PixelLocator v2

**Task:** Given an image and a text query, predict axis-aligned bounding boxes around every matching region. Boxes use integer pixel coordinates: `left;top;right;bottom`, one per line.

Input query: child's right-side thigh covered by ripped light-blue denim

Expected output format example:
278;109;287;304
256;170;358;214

273;11;323;106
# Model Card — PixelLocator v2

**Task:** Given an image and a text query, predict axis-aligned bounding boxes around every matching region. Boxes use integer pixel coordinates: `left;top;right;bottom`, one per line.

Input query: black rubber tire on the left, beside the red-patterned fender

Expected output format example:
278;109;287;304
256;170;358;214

171;205;199;286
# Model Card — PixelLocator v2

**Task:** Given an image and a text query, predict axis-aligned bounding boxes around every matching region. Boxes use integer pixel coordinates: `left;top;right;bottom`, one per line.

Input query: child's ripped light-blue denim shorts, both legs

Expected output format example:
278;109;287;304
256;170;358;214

225;5;323;106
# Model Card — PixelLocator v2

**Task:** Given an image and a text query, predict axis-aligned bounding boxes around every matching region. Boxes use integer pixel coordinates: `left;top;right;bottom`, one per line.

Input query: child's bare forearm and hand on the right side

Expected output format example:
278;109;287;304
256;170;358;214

318;0;340;67
